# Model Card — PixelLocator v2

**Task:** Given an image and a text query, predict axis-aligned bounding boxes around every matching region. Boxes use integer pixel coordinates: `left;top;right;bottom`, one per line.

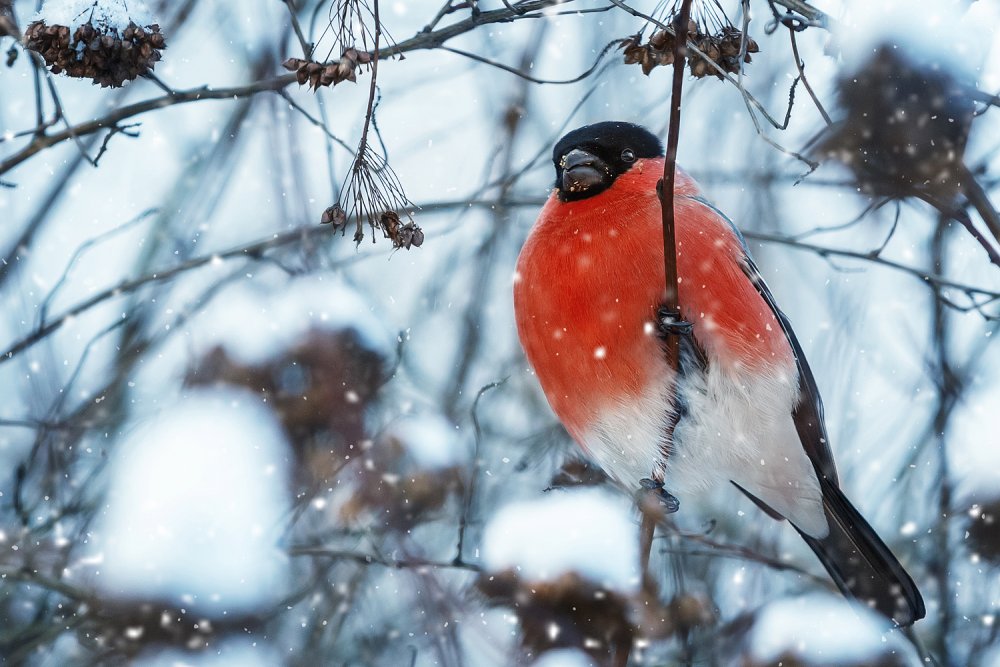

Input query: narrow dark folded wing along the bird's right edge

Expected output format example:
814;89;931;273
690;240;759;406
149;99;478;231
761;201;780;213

691;196;840;486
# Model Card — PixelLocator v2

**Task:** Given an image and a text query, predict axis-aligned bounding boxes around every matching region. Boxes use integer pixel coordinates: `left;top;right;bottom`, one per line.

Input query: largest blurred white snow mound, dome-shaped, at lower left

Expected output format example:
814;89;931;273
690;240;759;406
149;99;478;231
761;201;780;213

94;390;288;614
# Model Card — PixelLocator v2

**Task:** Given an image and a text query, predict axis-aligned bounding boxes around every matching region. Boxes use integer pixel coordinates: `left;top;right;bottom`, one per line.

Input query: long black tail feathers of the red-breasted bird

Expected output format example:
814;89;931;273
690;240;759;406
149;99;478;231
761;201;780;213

796;479;925;626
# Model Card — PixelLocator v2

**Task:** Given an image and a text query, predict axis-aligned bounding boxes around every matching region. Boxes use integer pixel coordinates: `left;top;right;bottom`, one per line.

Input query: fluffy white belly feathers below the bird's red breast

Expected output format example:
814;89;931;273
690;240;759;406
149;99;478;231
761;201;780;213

584;364;828;537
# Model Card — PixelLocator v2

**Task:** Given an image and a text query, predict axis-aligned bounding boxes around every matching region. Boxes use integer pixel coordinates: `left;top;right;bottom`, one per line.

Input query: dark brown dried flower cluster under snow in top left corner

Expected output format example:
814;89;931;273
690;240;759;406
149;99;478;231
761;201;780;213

24;21;166;88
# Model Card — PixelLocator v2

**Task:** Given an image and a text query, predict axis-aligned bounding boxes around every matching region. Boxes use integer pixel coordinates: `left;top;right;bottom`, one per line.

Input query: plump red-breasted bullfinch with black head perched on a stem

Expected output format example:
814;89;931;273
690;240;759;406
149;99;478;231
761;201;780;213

514;122;924;625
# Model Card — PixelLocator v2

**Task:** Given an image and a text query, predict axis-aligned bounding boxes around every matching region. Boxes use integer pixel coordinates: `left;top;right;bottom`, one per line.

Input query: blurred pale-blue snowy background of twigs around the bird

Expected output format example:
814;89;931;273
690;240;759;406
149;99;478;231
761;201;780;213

0;0;1000;667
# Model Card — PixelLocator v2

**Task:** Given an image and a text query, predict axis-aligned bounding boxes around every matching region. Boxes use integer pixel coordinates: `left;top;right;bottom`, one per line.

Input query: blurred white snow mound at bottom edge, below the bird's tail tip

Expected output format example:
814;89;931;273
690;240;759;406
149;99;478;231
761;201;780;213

750;595;911;664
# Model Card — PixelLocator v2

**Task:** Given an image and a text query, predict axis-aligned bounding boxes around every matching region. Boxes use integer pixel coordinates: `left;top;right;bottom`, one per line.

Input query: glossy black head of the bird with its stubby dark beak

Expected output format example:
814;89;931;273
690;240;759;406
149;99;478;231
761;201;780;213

552;121;663;201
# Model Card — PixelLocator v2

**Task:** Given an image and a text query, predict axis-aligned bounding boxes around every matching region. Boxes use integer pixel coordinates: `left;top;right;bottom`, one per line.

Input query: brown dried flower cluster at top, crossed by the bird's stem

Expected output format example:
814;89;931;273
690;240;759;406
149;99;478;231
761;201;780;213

619;20;760;79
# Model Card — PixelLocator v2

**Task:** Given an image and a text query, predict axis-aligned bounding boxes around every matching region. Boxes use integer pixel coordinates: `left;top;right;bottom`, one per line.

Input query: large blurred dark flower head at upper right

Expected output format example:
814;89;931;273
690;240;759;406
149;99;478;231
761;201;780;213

817;45;976;198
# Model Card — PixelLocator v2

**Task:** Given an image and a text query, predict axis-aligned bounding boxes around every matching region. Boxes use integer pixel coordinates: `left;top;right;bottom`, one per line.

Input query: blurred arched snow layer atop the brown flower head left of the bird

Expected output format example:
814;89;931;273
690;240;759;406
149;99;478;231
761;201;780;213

200;276;395;364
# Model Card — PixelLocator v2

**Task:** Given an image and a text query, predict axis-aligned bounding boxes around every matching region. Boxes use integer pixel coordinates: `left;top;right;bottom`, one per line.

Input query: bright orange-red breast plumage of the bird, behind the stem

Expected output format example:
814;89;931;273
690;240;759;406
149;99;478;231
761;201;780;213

514;158;793;441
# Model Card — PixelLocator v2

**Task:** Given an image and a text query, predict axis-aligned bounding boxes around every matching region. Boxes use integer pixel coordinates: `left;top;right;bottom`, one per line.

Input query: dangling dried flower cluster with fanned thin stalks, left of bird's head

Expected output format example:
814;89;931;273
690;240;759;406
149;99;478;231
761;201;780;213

320;144;424;250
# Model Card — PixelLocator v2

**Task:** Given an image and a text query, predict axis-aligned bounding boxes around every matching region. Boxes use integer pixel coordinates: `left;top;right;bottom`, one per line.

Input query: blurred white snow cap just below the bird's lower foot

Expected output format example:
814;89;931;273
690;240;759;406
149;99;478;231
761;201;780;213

483;489;639;593
